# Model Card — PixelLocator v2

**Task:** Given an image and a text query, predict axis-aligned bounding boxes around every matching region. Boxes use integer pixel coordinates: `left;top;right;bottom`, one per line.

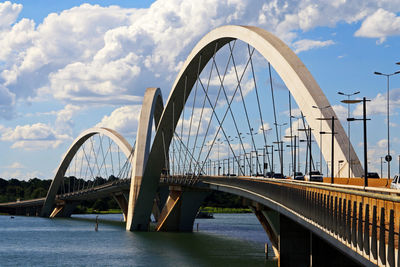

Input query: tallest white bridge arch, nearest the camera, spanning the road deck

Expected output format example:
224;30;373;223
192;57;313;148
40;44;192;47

146;26;363;184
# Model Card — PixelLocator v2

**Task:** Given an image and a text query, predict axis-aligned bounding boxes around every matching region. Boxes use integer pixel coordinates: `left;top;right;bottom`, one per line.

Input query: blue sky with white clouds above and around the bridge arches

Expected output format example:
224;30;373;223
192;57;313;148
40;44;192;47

0;0;400;179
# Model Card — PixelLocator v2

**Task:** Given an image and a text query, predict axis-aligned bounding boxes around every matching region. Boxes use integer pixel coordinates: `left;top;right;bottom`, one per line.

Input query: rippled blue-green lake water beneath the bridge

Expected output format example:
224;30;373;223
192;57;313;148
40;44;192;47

0;214;275;266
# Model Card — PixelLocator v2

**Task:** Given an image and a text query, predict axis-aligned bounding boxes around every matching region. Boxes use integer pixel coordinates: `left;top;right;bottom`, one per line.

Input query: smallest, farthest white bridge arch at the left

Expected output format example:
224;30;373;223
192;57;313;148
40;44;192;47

41;128;132;217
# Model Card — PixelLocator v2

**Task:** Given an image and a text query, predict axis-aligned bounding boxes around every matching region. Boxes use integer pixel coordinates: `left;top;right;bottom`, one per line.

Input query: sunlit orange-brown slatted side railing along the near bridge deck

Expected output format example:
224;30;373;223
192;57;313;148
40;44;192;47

195;177;400;266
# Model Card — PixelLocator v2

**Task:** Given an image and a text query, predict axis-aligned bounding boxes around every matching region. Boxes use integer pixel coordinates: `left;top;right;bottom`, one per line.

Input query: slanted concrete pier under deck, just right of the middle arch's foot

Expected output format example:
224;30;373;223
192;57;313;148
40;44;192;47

156;186;209;232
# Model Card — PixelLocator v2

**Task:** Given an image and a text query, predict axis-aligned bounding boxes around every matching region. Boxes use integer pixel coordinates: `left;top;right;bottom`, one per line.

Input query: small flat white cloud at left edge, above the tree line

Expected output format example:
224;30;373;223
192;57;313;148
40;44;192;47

0;123;70;150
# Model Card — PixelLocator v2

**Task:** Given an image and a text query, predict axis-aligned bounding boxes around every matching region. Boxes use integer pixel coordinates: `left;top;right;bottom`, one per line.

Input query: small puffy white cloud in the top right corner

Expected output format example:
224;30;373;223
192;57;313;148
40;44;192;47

354;8;400;43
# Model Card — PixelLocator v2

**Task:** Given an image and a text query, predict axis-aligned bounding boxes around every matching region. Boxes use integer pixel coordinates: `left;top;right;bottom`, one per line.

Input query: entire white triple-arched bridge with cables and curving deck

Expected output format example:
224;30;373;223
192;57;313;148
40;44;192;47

0;26;400;266
